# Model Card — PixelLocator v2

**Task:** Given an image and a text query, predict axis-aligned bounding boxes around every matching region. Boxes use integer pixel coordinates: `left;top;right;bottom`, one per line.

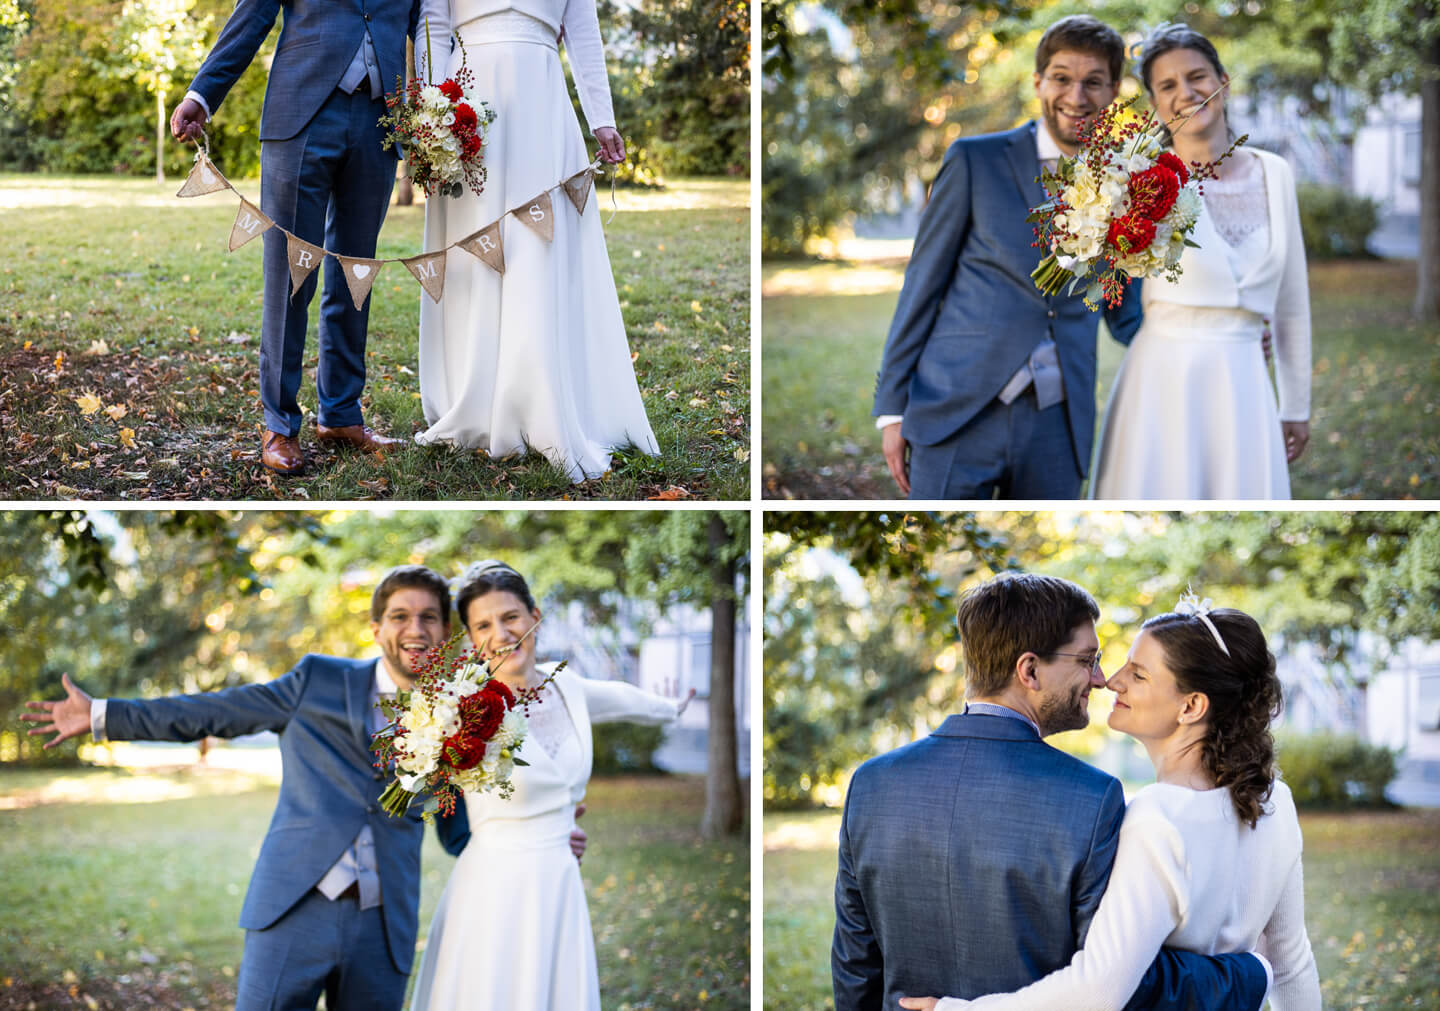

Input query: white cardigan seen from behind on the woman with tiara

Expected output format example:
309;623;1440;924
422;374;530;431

936;781;1320;1011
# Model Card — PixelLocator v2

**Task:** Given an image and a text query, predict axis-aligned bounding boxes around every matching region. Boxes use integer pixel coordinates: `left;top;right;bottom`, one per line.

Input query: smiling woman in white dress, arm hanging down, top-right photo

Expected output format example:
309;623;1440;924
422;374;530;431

1090;24;1310;500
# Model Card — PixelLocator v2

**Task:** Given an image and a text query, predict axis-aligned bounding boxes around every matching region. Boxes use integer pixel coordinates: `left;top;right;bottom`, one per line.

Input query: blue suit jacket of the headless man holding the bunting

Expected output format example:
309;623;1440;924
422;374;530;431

190;0;420;141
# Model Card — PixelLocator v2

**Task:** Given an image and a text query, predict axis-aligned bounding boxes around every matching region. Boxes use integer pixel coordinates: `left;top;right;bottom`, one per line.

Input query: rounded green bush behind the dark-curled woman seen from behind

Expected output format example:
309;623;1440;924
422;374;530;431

1276;733;1397;809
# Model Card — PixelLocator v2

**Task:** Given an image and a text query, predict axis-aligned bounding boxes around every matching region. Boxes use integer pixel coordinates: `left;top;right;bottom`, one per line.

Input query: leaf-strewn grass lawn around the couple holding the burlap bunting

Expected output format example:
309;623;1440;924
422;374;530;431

0;176;750;501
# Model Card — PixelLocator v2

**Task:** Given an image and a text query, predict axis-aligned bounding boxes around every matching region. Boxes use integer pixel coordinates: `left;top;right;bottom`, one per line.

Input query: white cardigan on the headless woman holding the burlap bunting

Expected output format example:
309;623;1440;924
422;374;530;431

415;0;615;134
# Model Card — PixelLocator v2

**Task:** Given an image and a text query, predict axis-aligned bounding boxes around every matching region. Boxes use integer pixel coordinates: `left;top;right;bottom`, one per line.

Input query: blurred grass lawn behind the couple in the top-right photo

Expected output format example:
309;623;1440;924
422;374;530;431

762;261;1440;498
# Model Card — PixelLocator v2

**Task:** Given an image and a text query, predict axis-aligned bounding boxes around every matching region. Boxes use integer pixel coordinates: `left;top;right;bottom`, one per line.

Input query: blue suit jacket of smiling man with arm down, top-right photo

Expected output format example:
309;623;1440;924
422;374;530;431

874;121;1140;474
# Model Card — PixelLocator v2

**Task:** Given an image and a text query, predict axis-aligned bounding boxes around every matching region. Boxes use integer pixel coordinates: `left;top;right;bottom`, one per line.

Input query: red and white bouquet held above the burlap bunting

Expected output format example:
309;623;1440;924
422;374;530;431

380;23;495;197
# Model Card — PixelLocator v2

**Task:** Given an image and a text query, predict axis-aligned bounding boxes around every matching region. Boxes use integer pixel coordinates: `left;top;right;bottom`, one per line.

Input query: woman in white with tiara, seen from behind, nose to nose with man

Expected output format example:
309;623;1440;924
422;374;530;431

900;605;1320;1011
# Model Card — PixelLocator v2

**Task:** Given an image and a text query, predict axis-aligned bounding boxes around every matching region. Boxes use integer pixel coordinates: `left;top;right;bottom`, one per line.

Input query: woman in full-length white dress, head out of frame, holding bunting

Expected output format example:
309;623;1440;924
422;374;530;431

416;0;660;481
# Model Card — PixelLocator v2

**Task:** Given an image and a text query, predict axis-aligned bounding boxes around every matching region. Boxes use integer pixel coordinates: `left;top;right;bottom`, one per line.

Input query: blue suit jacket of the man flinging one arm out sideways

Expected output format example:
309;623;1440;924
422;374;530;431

105;654;469;974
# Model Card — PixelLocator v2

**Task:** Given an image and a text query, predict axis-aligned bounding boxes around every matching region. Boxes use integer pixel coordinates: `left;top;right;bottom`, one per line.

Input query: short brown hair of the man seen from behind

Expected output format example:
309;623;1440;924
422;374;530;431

955;572;1100;698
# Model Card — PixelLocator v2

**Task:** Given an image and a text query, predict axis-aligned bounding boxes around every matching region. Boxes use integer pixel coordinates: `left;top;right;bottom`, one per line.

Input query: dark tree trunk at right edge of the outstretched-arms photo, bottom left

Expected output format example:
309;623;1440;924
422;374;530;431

700;516;744;840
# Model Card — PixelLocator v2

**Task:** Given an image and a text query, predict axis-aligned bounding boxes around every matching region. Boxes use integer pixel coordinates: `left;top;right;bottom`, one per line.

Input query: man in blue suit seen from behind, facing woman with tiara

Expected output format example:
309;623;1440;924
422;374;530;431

831;573;1267;1011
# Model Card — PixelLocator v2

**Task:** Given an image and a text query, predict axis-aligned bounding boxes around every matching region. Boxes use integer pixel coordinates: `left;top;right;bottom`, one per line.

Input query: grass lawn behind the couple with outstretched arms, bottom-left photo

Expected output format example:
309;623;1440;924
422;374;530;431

0;766;750;1011
